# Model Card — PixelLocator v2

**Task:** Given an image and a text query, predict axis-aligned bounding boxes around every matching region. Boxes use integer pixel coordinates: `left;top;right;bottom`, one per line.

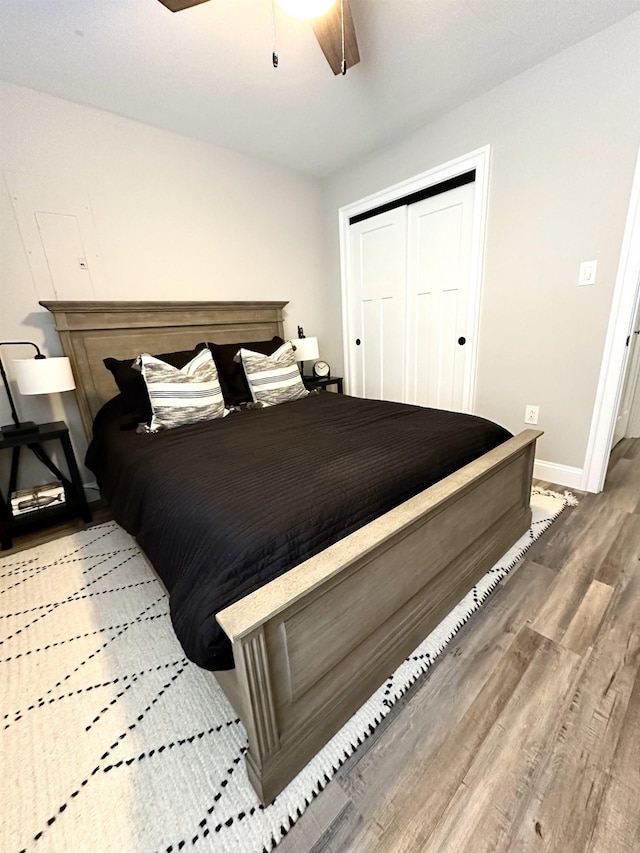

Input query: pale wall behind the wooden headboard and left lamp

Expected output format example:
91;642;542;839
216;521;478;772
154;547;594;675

0;83;328;481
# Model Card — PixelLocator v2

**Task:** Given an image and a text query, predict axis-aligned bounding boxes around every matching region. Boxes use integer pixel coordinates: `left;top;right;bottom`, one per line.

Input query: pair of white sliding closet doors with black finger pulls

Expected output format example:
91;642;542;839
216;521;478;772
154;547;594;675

347;183;474;411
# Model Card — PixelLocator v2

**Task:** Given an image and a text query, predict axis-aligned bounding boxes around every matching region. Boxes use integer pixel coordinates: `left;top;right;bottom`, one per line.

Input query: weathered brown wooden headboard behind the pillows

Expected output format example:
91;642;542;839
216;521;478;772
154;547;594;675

40;302;287;439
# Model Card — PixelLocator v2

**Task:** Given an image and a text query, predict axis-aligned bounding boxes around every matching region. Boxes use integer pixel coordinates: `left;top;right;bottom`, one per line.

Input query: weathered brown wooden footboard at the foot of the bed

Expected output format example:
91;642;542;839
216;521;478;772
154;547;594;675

216;430;542;803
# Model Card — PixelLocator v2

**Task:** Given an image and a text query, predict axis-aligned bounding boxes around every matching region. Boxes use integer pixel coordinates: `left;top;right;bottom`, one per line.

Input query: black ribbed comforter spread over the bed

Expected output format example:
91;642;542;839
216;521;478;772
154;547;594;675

87;393;510;669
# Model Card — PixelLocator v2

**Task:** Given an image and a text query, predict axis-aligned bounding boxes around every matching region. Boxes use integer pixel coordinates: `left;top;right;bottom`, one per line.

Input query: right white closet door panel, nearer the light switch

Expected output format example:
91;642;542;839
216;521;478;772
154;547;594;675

406;184;474;411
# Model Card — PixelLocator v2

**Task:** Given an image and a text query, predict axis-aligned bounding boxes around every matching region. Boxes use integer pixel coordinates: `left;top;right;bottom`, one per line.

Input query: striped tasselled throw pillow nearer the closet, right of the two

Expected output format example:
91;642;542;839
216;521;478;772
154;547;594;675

235;341;309;406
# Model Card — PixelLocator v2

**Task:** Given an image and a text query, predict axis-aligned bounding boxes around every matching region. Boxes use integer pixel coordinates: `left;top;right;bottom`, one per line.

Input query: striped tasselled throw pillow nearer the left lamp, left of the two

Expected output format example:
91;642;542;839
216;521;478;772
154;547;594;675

135;349;227;432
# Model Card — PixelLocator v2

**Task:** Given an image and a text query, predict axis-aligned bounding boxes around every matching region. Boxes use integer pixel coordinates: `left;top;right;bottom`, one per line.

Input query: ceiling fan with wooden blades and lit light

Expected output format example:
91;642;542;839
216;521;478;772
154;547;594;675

160;0;360;74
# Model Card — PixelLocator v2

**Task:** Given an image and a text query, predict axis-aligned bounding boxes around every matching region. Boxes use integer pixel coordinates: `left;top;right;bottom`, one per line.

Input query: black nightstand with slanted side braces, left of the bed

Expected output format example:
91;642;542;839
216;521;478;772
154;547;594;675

0;421;91;549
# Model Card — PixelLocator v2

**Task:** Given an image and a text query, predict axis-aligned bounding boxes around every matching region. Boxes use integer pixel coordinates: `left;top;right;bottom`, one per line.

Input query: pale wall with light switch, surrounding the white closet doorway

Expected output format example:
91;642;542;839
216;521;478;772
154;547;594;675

325;13;640;482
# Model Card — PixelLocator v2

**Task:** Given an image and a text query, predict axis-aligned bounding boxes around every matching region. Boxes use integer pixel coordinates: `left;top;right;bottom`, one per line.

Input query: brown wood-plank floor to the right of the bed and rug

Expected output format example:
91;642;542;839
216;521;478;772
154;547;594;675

277;439;640;853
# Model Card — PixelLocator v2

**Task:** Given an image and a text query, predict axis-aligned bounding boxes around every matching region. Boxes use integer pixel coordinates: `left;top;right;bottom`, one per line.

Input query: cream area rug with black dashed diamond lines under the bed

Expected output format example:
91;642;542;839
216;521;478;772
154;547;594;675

0;489;575;853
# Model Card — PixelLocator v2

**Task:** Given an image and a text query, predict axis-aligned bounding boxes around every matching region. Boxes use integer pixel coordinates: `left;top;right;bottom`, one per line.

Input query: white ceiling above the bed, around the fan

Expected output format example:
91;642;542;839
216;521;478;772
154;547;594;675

0;0;640;175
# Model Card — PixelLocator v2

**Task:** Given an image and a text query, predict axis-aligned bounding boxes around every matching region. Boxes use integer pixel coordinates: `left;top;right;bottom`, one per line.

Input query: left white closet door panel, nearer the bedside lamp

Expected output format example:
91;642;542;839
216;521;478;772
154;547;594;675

348;207;407;402
